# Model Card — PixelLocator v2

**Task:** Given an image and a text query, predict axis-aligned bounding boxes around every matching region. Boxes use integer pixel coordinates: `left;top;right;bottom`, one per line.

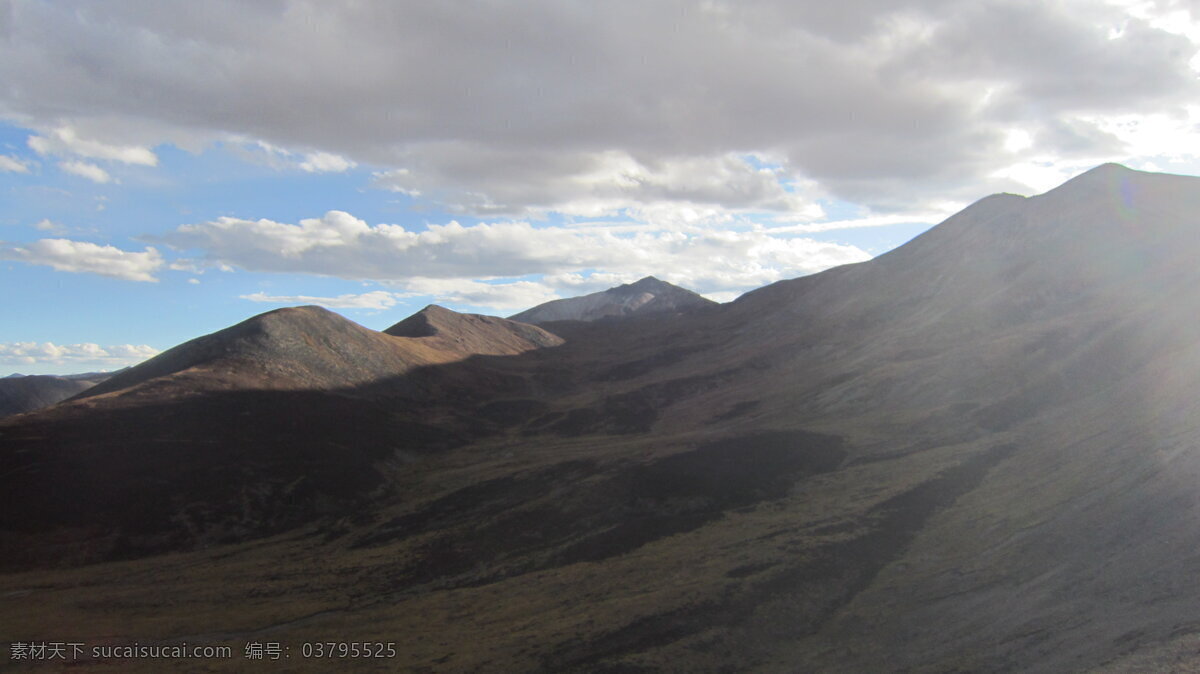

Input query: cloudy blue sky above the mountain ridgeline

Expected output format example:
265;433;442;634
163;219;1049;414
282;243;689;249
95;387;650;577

0;0;1200;375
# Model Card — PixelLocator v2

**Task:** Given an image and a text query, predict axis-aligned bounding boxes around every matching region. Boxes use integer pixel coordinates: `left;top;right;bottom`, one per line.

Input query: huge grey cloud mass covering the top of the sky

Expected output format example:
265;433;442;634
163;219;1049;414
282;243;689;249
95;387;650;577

0;0;1200;214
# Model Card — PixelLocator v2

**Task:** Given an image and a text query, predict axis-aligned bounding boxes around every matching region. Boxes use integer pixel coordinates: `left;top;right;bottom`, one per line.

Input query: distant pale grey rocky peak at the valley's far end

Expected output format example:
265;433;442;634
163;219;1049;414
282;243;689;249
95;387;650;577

509;276;716;324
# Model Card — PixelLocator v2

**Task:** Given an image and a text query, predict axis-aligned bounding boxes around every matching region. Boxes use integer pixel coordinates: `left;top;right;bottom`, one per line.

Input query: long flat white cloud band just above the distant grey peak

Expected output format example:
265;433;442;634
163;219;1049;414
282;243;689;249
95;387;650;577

154;211;869;293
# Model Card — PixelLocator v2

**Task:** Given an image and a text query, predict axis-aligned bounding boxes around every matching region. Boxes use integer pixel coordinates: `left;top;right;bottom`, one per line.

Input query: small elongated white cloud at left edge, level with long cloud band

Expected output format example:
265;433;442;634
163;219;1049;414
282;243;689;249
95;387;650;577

0;239;163;282
